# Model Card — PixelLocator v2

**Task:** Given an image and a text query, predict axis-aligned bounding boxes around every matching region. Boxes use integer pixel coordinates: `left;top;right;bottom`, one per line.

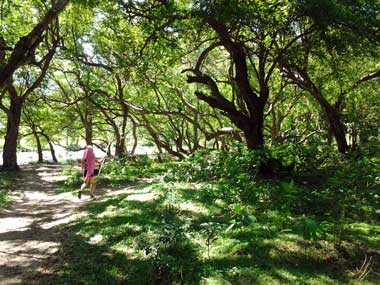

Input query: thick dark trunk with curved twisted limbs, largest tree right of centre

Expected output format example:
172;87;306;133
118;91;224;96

187;17;271;149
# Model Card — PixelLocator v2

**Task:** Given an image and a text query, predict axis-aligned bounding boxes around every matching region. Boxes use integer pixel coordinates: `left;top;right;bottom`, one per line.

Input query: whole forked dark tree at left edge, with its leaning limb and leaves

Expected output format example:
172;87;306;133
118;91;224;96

0;0;68;170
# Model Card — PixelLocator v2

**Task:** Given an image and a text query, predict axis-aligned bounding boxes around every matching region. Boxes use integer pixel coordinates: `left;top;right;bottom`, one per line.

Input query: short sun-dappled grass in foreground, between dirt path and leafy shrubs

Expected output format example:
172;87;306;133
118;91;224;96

43;182;380;284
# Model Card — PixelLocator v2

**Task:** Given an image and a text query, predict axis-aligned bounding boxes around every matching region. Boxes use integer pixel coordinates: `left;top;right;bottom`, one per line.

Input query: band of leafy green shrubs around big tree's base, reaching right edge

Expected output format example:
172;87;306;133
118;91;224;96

164;142;380;220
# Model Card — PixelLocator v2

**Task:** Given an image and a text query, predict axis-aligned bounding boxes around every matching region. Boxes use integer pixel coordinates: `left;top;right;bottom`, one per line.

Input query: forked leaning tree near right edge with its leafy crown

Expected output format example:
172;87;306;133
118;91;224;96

279;1;380;153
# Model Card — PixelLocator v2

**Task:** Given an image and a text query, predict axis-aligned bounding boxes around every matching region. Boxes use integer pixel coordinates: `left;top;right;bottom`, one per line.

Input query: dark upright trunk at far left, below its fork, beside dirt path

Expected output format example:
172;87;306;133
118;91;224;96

3;96;24;170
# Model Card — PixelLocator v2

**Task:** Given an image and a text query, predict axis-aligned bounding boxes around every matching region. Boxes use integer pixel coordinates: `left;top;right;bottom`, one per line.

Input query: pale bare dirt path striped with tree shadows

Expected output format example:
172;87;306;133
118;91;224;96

0;165;88;285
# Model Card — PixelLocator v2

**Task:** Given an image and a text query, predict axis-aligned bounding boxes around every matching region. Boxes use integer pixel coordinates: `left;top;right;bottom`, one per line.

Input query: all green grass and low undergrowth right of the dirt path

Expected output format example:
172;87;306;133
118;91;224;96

45;149;380;285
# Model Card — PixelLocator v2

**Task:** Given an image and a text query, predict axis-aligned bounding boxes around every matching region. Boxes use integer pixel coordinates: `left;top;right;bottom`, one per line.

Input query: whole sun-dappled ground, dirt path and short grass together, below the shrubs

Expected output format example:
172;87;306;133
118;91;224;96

0;161;380;285
